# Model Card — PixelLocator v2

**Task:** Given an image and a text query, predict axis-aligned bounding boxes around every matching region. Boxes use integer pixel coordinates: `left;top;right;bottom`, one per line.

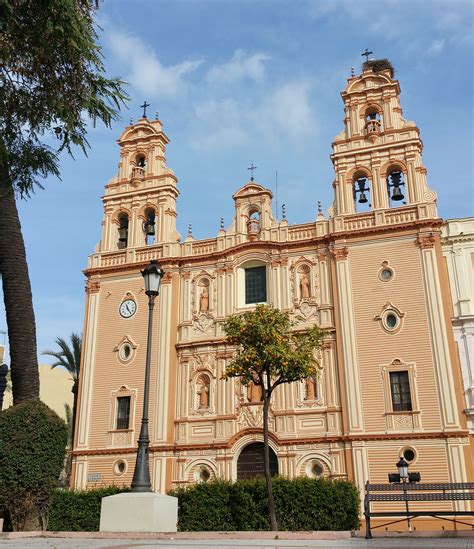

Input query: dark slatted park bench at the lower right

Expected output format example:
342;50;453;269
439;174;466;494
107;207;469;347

364;482;474;539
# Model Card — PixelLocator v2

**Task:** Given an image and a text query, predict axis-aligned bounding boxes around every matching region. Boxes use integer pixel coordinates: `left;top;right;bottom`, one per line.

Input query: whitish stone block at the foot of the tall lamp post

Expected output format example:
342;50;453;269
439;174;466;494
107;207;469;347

100;492;178;532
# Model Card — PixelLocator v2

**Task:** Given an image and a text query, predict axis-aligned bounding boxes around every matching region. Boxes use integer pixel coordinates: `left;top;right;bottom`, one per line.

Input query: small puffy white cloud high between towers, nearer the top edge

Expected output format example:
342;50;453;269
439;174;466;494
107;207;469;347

206;50;270;84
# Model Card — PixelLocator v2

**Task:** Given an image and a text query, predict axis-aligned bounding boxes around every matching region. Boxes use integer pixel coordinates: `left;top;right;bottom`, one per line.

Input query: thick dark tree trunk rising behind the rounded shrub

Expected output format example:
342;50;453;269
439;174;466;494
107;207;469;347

0;176;39;404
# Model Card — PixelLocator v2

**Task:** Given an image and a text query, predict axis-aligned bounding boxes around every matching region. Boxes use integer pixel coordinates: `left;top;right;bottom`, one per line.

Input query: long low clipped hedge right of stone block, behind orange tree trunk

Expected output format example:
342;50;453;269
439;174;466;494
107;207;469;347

169;477;359;531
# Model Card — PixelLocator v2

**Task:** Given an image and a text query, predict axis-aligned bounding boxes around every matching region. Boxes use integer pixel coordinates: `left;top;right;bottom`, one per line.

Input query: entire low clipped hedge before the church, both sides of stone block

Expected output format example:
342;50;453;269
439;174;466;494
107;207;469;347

48;477;359;532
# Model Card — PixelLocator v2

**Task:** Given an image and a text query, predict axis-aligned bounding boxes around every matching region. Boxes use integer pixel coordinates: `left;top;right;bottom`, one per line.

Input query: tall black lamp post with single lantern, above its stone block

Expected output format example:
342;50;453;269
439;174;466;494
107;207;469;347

131;261;164;492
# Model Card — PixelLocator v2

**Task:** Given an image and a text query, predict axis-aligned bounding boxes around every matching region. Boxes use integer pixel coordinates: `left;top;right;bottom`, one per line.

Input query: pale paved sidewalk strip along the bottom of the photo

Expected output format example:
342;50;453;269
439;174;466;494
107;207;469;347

0;537;474;549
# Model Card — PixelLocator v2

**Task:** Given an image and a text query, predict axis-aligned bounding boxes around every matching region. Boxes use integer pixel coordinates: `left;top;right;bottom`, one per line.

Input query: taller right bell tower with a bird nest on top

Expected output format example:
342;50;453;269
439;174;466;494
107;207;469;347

331;59;437;220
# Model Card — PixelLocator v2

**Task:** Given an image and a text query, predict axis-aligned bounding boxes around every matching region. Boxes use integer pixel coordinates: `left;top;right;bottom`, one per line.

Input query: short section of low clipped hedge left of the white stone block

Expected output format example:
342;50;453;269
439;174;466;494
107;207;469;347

48;486;130;532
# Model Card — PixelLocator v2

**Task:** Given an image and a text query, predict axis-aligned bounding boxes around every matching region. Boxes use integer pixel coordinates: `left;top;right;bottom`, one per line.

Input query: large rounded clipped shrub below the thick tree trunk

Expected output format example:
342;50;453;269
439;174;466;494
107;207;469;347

0;400;67;530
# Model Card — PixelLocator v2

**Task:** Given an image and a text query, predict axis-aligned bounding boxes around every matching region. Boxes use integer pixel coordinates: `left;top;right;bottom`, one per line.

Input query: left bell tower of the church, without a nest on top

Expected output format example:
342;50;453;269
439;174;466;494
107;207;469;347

97;117;180;252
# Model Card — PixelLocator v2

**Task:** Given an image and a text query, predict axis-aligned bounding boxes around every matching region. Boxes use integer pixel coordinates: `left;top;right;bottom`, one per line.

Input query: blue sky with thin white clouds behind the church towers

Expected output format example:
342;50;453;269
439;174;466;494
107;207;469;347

0;0;474;362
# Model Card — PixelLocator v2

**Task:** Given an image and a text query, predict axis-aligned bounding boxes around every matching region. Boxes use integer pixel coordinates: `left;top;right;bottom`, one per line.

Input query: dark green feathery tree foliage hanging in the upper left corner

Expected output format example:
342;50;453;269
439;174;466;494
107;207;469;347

0;0;127;196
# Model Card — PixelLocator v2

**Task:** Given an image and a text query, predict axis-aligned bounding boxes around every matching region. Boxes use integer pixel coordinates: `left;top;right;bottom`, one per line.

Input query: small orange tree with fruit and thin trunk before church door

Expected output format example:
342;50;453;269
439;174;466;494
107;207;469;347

222;305;324;530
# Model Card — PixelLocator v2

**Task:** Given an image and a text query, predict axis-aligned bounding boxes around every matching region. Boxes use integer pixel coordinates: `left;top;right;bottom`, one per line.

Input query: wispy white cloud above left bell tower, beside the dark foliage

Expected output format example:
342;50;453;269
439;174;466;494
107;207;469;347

107;32;203;98
